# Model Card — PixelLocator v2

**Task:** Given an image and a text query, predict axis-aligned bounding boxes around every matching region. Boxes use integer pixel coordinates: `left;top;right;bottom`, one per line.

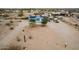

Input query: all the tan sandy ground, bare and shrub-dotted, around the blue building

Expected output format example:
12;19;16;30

0;17;79;50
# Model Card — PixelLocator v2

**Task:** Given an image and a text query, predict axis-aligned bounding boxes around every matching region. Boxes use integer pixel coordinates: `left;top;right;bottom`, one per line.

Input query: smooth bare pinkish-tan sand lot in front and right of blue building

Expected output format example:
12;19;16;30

27;19;79;50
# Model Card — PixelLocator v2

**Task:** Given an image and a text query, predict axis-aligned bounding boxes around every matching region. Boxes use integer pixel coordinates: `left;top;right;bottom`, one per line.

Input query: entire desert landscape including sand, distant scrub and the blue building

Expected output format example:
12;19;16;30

0;8;79;50
